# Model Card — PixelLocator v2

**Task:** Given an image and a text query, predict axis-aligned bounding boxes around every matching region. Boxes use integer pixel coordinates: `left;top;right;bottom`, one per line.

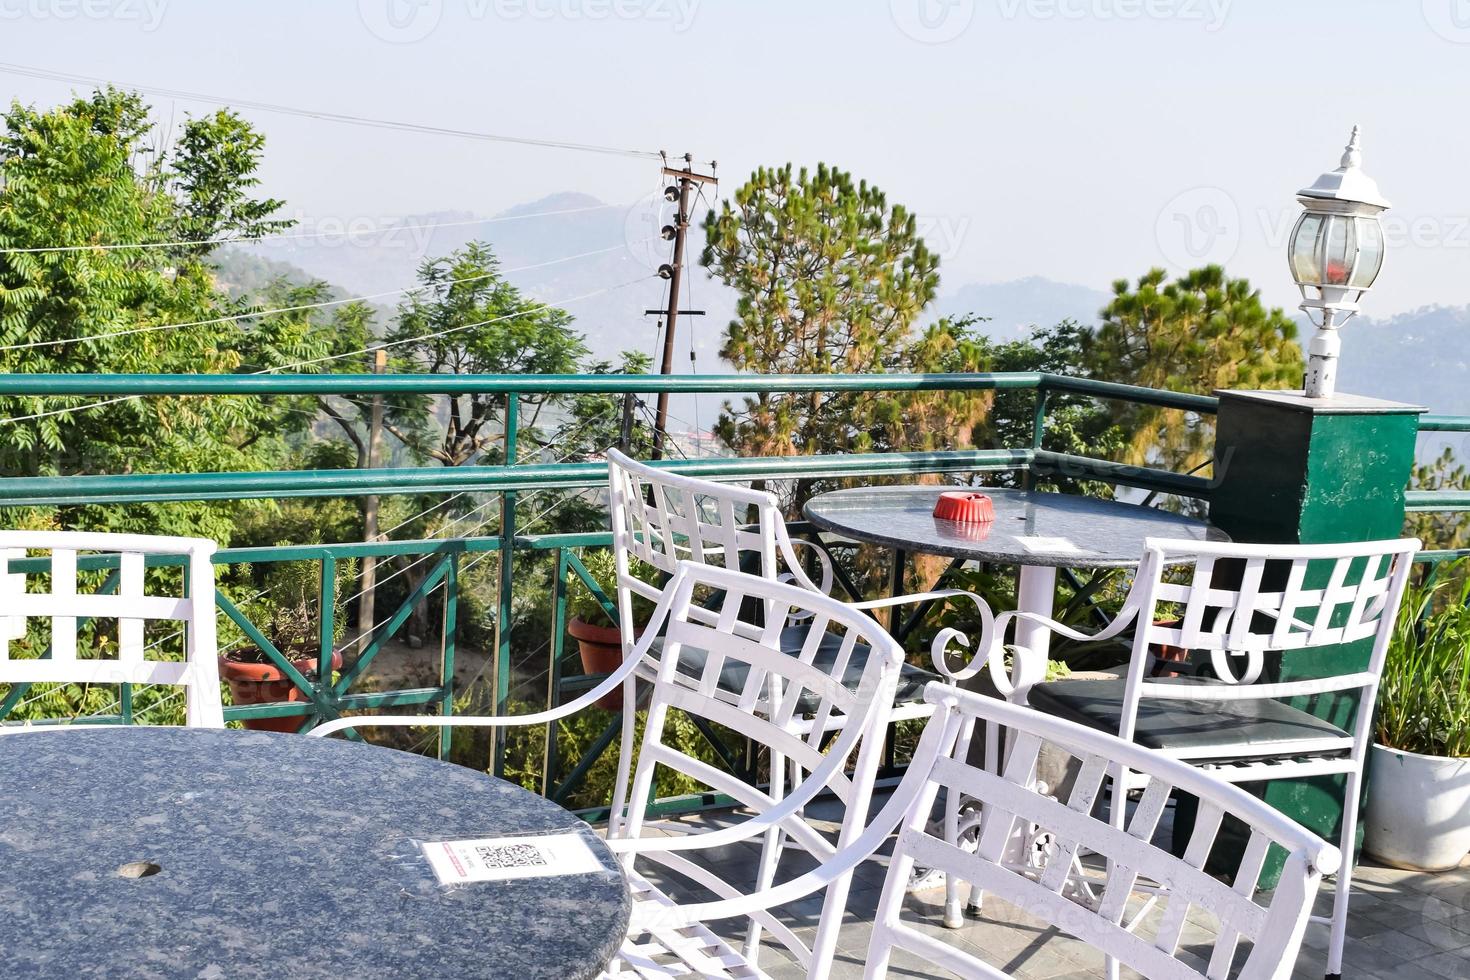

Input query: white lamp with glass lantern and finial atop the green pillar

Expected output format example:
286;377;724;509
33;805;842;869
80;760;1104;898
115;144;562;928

1288;126;1389;398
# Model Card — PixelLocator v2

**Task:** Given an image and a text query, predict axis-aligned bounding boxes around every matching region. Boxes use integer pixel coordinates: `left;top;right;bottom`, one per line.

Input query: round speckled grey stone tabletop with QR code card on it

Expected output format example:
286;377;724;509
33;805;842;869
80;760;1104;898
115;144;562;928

0;726;631;980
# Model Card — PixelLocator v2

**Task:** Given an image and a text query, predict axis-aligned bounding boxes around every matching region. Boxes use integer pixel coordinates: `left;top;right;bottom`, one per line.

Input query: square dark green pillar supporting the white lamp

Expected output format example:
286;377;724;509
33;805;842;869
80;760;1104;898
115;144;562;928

1210;391;1424;877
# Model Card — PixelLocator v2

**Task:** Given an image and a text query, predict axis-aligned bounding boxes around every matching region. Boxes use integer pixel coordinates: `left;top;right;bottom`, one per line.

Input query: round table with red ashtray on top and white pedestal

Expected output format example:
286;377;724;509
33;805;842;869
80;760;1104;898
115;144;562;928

804;486;1229;652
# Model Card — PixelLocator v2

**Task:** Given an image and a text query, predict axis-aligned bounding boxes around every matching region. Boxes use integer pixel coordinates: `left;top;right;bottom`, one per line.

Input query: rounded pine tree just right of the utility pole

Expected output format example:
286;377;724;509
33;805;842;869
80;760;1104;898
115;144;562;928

701;165;989;501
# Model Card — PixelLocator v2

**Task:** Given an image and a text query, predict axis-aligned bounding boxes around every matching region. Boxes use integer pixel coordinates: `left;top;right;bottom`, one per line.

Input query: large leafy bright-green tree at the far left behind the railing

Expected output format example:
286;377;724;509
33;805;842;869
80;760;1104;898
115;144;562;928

0;88;322;541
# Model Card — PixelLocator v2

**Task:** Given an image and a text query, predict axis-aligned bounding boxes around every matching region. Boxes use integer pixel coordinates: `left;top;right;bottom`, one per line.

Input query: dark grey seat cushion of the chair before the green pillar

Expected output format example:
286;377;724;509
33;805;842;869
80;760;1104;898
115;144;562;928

1030;677;1349;758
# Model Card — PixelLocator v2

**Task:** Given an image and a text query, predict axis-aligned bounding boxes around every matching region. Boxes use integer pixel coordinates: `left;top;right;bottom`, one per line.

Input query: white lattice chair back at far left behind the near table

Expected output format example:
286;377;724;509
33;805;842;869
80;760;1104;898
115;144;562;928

0;530;225;733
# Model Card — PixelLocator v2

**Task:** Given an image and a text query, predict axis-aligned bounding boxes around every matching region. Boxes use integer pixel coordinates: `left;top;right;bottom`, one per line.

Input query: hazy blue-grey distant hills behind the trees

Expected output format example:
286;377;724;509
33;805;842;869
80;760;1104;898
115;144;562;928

221;192;1470;457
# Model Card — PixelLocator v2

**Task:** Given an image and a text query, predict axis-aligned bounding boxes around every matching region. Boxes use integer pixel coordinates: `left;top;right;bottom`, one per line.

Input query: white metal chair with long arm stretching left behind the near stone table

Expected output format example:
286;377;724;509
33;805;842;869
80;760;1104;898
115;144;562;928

312;561;903;976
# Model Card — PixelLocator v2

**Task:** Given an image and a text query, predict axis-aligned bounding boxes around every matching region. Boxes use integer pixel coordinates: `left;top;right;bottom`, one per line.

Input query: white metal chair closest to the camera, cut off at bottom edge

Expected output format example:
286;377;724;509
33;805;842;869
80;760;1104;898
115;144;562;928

609;685;1339;980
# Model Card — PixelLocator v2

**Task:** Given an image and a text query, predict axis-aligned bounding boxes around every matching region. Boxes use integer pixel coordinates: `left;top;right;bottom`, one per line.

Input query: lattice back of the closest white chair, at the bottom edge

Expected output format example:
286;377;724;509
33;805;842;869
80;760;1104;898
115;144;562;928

866;685;1341;980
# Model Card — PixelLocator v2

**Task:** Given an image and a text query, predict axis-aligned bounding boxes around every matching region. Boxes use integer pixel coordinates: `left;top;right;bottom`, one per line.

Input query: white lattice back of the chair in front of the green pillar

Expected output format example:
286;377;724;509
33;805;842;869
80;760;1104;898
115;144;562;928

1122;538;1420;738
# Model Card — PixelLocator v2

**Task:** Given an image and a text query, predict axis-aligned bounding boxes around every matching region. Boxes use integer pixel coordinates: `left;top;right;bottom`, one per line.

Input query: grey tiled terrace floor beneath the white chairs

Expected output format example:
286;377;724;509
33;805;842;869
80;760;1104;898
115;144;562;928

635;805;1470;980
